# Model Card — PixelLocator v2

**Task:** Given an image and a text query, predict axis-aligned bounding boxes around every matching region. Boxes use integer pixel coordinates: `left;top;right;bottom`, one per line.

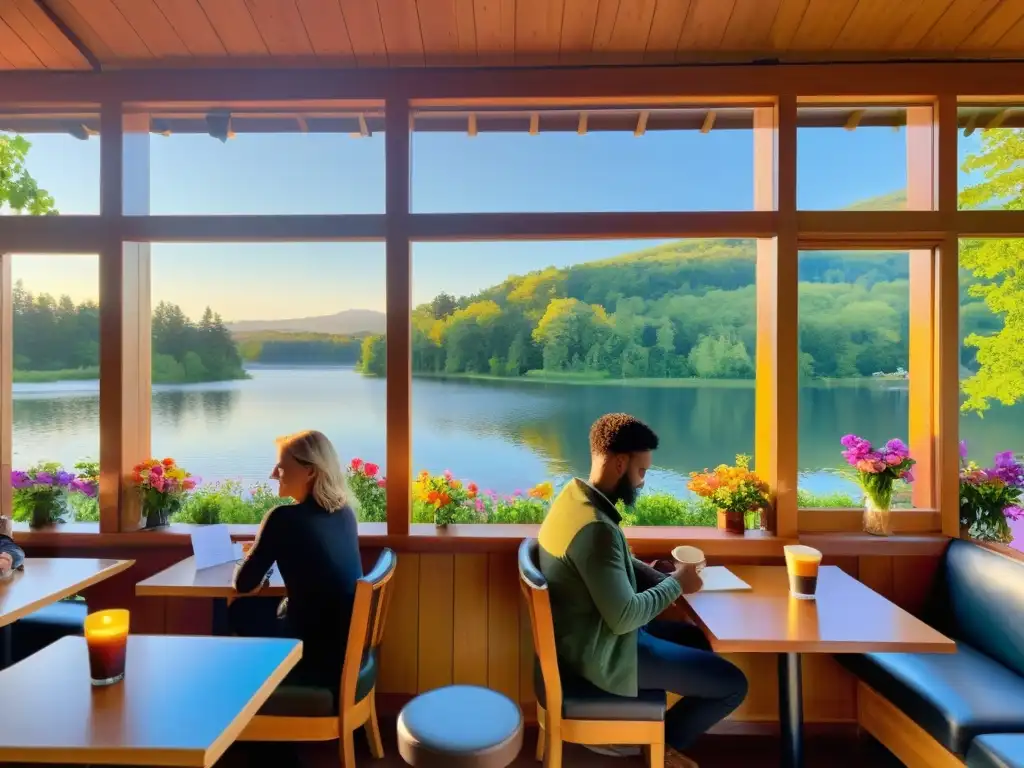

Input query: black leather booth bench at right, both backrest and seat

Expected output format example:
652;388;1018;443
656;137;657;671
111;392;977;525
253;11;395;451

840;541;1024;765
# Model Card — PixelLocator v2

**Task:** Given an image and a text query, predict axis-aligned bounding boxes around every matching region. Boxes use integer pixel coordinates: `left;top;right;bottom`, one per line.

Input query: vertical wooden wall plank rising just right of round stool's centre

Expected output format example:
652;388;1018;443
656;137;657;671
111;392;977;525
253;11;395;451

452;555;488;685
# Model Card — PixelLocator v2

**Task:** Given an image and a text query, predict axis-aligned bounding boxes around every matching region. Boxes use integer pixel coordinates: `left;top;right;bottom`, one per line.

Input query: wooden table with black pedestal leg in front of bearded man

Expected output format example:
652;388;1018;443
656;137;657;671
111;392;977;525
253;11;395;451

684;565;956;767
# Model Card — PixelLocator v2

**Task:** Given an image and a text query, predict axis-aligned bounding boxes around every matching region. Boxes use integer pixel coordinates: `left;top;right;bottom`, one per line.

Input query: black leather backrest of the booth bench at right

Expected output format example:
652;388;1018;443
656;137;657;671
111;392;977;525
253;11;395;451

943;539;1024;675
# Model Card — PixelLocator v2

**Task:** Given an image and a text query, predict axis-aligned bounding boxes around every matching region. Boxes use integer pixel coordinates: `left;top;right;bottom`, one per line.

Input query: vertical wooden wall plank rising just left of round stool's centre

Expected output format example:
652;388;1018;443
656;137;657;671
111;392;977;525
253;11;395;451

417;555;456;692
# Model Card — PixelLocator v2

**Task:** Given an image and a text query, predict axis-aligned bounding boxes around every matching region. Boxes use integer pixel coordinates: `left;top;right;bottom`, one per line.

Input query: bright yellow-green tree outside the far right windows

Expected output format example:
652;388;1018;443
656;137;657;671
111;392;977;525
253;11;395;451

959;129;1024;412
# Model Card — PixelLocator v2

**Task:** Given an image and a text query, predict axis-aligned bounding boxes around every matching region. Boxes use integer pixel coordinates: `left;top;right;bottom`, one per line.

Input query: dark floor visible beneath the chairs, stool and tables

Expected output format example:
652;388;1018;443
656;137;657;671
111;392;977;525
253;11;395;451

211;723;901;768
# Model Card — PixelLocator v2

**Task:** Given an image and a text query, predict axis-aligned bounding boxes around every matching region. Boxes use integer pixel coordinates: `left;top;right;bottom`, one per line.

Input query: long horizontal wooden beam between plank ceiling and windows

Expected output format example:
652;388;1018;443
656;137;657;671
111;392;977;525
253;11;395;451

0;61;1024;110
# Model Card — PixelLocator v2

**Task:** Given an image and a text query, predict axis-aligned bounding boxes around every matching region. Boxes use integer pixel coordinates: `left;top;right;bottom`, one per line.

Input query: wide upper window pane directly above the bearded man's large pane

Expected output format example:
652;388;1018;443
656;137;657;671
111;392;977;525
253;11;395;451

412;108;754;213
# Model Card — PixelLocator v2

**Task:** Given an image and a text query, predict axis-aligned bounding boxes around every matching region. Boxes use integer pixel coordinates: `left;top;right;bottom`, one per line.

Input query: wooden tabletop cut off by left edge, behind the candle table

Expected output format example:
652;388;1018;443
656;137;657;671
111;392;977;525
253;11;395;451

0;557;135;627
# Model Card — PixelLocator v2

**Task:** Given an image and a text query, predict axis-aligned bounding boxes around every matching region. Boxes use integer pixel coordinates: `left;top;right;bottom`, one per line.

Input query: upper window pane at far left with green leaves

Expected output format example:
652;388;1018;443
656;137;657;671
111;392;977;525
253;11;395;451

0;109;99;215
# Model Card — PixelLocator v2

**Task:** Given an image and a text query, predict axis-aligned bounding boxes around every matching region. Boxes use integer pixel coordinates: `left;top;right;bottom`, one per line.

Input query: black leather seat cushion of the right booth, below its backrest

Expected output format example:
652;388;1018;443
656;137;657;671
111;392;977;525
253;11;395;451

839;643;1024;755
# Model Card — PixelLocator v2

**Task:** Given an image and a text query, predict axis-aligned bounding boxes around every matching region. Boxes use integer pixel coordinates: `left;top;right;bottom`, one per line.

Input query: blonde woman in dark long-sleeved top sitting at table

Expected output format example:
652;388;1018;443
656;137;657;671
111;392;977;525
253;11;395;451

229;431;362;695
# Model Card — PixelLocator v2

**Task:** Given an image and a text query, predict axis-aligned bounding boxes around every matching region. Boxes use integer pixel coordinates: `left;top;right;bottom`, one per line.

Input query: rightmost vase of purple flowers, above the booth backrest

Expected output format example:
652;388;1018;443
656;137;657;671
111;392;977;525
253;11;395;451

959;441;1024;544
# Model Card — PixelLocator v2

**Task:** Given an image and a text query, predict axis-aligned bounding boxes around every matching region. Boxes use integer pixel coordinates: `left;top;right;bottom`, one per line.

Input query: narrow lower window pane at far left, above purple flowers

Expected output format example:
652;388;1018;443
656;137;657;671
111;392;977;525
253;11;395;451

11;254;99;521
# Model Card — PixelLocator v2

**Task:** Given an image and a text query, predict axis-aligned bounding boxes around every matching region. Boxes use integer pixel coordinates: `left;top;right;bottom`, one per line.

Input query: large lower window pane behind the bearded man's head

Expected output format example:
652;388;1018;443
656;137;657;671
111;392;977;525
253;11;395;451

413;240;756;525
